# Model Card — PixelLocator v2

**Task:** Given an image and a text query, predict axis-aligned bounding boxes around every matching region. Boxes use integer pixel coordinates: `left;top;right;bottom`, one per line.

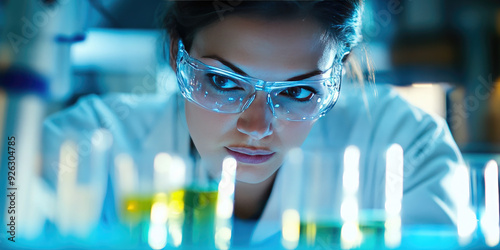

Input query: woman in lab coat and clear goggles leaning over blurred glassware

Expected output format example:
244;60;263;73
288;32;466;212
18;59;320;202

41;0;462;246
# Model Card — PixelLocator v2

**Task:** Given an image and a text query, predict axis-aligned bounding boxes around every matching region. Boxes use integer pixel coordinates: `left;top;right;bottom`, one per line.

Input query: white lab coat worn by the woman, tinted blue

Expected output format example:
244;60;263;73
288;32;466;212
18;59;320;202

43;84;463;246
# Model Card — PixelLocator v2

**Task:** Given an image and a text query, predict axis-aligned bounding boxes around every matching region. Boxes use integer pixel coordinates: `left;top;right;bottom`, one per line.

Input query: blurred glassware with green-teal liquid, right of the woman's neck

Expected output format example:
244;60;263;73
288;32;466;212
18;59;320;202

282;145;403;249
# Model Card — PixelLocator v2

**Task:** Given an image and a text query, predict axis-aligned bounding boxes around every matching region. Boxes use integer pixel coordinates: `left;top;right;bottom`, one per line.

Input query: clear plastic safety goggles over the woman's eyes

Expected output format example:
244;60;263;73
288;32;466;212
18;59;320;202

176;40;342;121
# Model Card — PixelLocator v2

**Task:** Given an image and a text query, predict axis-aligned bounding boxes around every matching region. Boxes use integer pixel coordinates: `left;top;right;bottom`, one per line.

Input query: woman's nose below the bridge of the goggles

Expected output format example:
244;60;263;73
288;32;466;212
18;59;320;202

236;92;274;140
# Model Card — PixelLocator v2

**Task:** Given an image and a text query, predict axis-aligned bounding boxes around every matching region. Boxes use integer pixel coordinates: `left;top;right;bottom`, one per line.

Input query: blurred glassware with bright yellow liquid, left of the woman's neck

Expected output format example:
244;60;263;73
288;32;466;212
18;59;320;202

114;152;236;249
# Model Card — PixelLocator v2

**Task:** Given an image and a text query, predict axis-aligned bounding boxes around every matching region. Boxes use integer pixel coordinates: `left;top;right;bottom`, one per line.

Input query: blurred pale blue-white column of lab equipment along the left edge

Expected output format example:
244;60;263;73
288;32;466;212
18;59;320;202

0;0;90;246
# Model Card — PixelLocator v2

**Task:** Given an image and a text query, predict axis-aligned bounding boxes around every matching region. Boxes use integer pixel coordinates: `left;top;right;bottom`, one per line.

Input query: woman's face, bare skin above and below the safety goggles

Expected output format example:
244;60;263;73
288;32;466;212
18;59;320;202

179;16;335;183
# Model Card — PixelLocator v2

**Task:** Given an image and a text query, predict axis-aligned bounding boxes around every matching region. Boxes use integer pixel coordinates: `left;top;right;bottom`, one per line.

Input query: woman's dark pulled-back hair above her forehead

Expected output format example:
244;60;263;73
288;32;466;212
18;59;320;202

162;0;363;62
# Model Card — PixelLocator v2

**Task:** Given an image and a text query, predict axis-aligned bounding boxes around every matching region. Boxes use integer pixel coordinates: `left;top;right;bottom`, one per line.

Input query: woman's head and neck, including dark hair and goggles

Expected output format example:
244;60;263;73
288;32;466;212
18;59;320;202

165;1;361;222
